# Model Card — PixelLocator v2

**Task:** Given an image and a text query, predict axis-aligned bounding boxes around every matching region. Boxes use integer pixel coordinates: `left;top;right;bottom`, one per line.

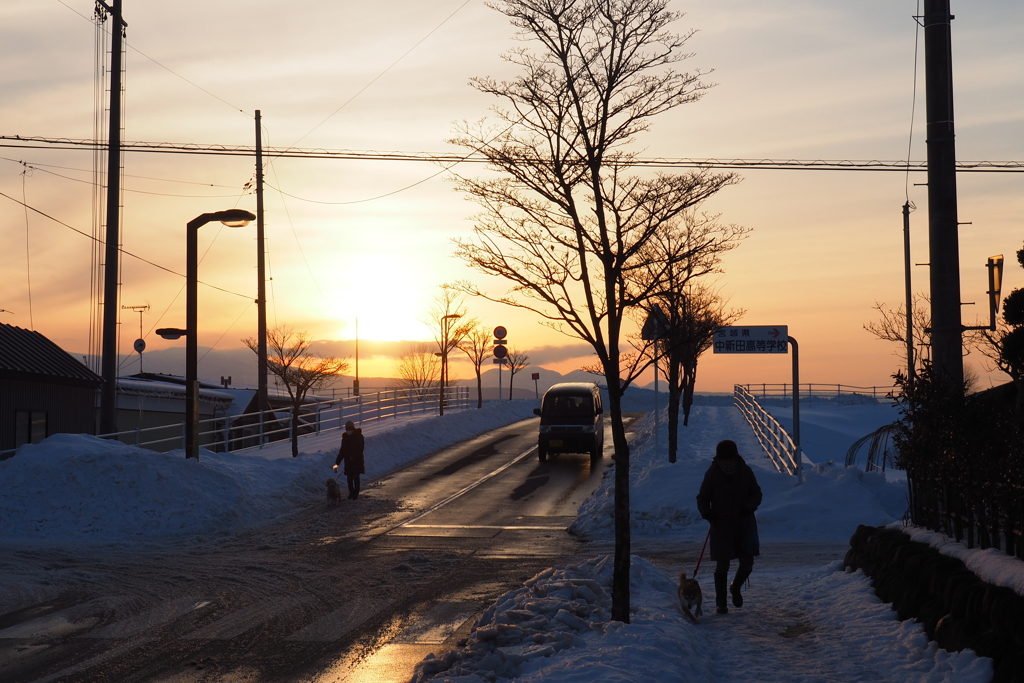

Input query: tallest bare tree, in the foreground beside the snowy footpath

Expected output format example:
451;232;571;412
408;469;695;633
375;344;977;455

453;0;738;622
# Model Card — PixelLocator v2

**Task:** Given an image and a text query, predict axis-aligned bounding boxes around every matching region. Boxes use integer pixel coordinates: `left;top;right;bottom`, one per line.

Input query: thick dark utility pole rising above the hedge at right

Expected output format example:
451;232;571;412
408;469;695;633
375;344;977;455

925;0;964;386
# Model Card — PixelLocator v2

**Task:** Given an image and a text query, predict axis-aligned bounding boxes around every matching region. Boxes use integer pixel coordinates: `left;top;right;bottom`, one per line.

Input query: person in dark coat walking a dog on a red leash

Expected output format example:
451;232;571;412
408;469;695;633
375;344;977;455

697;440;761;614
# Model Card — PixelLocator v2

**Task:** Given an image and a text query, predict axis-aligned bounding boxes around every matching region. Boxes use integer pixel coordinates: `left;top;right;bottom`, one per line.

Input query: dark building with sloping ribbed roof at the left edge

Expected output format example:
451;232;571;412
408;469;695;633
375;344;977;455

0;323;102;452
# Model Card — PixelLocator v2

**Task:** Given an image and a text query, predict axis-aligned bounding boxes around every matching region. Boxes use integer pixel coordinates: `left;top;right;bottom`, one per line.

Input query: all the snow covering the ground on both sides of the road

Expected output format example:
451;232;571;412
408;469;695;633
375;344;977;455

0;392;1024;683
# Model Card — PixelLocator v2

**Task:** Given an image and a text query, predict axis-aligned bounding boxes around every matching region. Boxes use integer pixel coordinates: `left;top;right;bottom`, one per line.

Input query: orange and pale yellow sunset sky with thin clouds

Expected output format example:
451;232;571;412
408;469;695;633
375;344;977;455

0;0;1024;391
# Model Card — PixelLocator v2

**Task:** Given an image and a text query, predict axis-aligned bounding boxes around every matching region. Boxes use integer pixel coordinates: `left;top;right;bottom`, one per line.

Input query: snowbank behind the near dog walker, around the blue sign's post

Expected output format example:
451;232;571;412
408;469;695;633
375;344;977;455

570;405;907;542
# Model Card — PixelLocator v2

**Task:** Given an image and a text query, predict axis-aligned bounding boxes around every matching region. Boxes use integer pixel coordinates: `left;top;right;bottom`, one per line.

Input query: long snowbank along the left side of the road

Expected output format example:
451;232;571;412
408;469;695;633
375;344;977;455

0;400;535;544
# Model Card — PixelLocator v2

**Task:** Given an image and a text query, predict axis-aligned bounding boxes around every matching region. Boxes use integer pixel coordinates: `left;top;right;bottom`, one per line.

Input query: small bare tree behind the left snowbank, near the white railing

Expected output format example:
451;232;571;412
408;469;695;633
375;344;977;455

242;326;348;458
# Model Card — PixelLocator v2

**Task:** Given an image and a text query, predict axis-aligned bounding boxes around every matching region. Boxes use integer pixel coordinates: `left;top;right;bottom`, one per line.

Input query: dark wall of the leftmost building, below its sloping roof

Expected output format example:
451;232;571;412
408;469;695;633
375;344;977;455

0;378;96;451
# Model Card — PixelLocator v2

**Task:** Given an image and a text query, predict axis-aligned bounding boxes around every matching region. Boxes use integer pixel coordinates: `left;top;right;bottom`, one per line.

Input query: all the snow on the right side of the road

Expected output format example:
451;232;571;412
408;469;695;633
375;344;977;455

414;401;1024;683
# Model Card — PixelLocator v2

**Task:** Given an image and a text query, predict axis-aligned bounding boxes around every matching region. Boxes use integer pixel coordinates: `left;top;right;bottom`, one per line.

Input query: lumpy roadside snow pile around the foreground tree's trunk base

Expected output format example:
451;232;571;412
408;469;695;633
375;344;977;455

413;556;711;683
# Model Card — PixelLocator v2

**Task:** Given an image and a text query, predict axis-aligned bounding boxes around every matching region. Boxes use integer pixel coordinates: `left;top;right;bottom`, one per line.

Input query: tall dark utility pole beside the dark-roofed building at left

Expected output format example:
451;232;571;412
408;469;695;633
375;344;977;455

97;0;128;434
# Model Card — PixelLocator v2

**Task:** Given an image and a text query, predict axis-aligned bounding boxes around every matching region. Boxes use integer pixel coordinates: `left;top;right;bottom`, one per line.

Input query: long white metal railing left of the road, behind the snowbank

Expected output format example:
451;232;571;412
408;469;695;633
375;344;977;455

90;386;470;452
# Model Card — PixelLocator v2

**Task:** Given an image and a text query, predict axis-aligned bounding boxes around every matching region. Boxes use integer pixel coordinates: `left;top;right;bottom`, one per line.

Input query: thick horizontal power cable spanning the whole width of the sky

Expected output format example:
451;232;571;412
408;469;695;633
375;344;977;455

0;135;1024;173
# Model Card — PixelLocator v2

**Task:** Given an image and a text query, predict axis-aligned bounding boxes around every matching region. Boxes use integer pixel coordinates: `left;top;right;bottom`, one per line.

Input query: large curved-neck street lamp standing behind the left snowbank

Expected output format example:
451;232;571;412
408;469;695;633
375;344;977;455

178;209;256;460
